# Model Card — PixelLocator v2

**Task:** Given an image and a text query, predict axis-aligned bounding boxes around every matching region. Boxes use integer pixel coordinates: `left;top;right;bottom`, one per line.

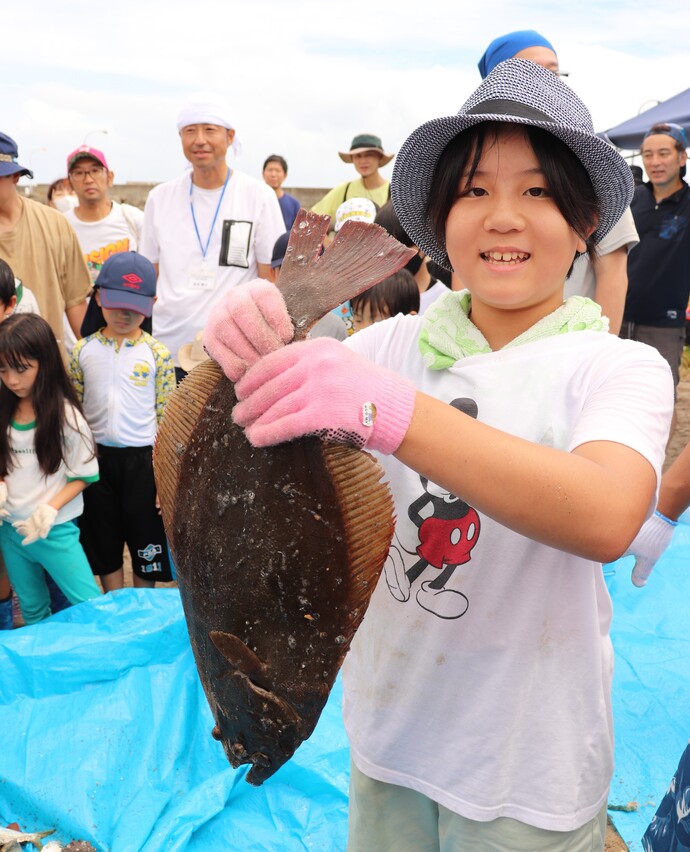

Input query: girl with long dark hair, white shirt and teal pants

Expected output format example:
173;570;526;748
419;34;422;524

0;314;100;624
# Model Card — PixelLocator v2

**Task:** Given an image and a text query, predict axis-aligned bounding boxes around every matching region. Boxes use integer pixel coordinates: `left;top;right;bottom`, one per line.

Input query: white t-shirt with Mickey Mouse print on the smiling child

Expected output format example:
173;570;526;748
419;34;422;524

343;316;673;831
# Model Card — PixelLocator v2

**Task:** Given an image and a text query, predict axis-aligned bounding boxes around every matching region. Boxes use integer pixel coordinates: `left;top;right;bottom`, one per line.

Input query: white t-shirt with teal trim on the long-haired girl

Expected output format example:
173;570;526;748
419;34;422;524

5;403;98;524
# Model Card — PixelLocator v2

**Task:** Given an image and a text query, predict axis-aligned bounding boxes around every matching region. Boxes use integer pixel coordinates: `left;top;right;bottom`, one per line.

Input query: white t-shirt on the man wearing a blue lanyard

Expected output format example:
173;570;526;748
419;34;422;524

139;169;285;364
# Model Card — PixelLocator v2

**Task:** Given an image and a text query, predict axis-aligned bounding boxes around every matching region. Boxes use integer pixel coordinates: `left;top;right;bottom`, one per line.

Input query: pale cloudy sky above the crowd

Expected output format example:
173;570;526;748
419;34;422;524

5;0;690;188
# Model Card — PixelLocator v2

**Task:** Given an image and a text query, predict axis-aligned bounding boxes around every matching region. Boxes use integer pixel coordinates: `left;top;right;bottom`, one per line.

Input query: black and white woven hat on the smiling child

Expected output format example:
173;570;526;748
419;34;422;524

391;59;634;269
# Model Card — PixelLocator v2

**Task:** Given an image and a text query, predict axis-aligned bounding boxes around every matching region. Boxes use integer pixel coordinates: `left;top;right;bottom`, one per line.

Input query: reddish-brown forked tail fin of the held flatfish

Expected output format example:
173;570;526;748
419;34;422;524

278;209;416;340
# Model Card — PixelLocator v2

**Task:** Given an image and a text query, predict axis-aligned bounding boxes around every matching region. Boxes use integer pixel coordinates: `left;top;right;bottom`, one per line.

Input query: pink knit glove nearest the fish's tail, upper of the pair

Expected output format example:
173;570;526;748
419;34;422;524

204;278;295;382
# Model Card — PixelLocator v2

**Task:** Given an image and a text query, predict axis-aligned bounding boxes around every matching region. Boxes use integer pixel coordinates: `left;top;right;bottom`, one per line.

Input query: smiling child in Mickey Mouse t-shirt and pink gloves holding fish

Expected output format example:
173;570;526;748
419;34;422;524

205;59;673;852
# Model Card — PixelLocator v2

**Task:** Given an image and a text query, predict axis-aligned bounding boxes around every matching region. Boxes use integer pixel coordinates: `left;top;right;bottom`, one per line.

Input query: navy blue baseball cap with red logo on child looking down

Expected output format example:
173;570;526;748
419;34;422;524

95;251;156;317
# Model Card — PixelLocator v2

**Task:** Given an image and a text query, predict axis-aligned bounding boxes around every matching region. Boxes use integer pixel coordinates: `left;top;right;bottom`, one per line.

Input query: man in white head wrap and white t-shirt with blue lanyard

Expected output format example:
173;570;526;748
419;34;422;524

139;101;285;380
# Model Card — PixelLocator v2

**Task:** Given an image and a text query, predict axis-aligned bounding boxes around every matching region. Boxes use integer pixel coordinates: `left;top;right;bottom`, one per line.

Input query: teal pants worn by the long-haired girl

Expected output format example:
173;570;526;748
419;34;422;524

0;521;101;624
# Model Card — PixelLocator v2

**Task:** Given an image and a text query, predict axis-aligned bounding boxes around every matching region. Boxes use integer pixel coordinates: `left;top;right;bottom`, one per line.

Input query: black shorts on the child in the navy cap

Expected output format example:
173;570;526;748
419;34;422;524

79;444;172;583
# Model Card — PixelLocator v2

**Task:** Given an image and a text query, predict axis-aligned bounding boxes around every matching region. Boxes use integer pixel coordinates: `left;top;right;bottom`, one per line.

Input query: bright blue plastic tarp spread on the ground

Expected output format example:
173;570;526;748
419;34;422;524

0;523;690;852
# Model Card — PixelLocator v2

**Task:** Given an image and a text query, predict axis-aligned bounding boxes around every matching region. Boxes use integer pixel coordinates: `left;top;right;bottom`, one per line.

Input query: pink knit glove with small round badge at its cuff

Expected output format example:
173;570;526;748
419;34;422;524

232;337;416;453
